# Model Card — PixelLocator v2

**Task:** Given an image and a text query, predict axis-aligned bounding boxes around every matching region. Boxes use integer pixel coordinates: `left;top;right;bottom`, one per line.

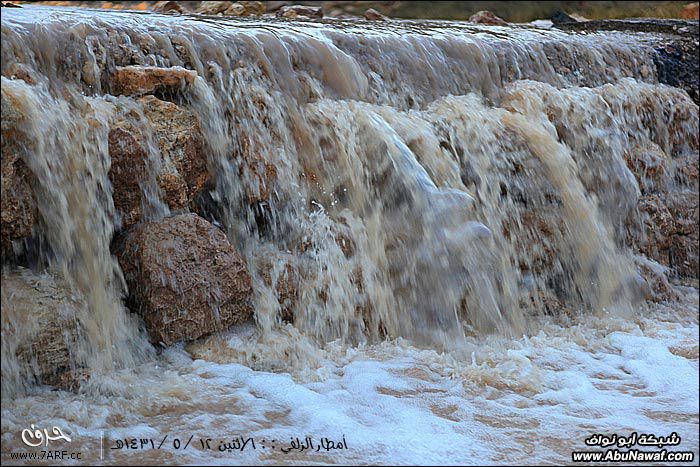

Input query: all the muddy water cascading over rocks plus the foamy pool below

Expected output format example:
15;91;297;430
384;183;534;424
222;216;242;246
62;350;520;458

2;7;699;462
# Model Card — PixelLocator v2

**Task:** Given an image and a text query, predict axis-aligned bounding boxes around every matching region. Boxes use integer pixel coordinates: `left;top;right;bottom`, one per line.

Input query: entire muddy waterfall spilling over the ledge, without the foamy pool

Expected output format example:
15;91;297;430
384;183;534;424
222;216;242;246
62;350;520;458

2;8;698;388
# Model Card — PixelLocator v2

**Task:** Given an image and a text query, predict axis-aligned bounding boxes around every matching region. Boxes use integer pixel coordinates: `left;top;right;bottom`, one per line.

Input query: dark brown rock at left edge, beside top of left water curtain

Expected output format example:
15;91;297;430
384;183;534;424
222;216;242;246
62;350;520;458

0;83;37;256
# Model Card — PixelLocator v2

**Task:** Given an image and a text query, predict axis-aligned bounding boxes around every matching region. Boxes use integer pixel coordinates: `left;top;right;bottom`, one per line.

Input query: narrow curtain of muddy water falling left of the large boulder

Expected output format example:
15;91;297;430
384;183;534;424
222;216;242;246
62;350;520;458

2;77;148;393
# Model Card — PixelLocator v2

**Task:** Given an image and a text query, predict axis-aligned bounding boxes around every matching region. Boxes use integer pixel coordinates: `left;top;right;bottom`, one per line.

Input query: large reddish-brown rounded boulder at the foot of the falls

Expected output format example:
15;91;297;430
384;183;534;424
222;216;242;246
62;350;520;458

116;213;253;345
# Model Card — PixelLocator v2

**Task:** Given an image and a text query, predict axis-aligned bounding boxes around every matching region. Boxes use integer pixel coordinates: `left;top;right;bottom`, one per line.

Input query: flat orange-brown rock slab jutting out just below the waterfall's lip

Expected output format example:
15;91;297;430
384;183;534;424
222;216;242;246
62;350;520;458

112;65;197;96
